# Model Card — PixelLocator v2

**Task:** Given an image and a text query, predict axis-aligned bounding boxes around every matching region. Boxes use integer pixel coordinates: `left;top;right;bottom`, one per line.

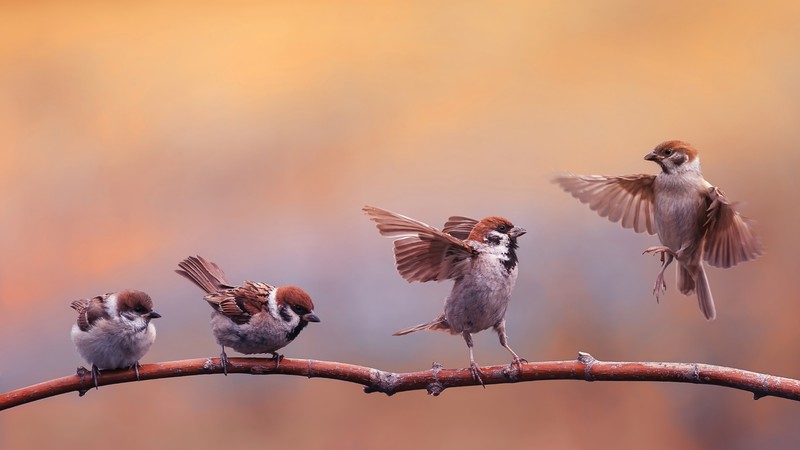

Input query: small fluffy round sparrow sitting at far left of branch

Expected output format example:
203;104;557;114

70;289;161;388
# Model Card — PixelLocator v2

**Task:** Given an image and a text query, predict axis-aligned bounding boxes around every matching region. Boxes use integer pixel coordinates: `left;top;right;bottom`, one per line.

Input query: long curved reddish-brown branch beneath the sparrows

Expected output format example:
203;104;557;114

0;352;800;410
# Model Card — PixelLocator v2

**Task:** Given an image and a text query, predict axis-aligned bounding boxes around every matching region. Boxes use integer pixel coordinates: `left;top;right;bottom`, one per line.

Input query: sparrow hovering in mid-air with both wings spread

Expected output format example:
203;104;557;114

554;141;762;320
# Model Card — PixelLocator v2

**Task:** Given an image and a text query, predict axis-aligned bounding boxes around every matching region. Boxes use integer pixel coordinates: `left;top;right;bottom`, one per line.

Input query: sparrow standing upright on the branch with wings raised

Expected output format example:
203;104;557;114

364;206;525;384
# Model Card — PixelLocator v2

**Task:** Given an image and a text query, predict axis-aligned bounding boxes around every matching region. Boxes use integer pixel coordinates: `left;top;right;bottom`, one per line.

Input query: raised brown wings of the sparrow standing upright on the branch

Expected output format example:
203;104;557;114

364;206;476;282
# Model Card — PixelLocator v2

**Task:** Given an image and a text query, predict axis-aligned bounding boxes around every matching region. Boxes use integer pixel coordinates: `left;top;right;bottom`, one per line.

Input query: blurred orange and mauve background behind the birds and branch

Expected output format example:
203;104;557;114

0;0;800;449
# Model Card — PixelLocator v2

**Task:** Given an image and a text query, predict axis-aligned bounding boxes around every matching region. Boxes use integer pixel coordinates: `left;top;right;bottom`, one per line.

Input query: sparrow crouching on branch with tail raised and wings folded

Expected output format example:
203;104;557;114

175;256;319;375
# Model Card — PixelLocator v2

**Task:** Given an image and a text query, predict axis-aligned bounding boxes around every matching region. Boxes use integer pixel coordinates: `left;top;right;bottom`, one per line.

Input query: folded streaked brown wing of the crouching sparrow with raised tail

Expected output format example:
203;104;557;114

203;281;275;325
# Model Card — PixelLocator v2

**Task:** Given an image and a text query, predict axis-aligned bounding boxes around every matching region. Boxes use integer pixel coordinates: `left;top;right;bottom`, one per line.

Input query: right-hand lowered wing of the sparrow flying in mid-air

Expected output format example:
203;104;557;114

705;186;763;268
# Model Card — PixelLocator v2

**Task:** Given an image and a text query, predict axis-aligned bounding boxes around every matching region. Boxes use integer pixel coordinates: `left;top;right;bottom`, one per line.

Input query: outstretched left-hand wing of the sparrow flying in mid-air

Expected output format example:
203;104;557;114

553;174;656;234
